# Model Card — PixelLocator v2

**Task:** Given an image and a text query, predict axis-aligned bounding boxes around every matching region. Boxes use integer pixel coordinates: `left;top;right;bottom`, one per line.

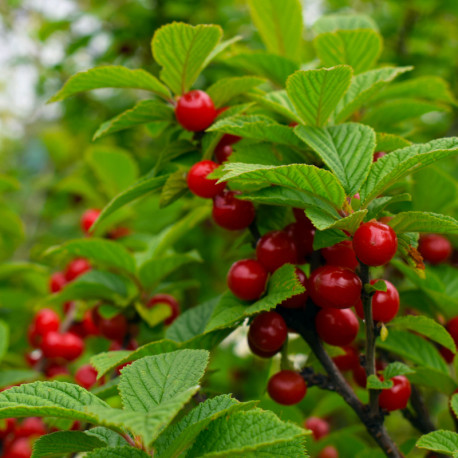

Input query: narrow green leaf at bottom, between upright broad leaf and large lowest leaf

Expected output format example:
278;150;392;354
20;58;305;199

154;394;256;458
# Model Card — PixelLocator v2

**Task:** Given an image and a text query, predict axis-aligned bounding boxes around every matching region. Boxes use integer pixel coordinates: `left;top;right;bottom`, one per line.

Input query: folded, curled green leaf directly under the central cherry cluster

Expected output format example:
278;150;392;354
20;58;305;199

206;264;304;331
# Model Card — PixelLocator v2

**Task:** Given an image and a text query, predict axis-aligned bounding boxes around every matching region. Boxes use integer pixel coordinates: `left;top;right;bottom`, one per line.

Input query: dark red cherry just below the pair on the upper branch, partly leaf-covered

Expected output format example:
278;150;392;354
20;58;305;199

212;191;256;231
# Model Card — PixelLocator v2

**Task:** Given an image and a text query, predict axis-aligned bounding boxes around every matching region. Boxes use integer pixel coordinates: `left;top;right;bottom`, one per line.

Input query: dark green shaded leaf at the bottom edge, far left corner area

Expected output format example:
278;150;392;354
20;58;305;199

32;431;106;458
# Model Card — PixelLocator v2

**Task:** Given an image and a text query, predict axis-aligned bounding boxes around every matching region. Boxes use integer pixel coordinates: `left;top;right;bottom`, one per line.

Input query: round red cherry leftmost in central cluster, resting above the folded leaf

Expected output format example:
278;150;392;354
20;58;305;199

227;259;268;301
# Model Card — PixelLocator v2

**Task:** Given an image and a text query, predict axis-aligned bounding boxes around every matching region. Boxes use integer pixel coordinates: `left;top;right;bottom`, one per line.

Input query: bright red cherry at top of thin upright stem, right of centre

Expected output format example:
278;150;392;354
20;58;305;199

353;221;398;266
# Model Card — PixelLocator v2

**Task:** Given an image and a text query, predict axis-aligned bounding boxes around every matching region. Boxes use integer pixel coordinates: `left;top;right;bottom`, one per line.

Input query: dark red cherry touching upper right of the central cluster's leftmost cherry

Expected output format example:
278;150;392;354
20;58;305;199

256;231;297;272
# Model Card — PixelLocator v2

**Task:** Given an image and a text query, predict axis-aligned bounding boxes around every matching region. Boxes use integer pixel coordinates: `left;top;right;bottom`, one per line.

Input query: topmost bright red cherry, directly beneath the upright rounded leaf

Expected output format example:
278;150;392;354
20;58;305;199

175;90;217;132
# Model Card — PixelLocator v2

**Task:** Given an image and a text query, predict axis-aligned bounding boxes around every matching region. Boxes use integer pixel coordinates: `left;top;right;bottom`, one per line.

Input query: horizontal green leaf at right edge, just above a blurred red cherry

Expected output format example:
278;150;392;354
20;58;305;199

390;212;458;234
